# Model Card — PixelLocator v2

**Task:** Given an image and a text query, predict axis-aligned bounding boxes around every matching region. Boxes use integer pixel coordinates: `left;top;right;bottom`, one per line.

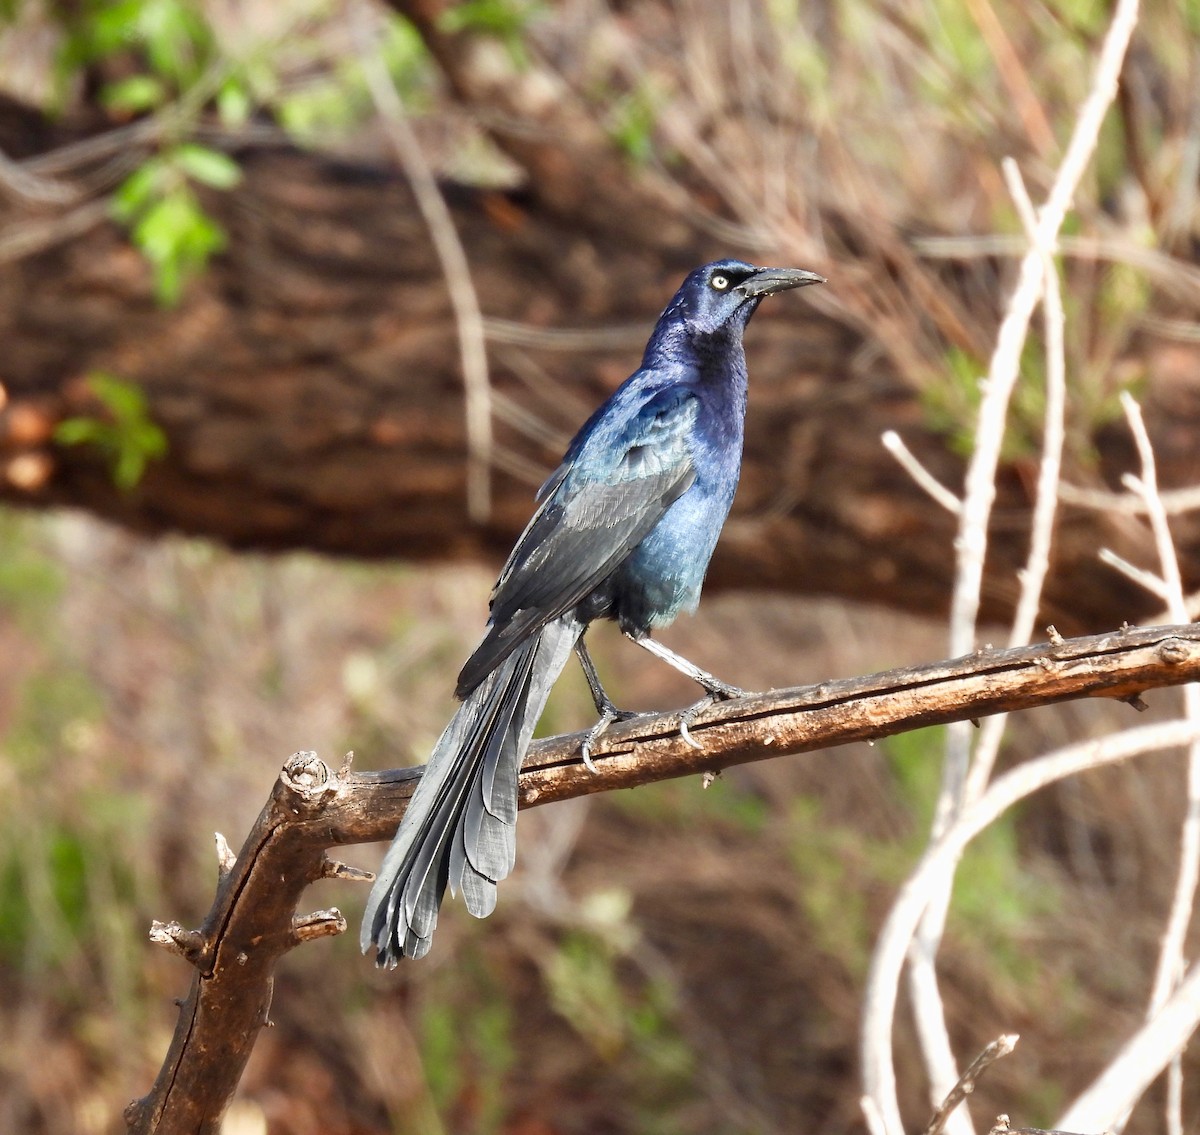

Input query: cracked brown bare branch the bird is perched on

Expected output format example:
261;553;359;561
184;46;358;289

133;626;1200;1135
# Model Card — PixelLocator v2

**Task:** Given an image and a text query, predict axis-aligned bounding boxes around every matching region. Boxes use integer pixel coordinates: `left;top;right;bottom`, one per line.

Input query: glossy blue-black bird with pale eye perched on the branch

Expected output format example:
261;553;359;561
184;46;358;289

360;259;824;967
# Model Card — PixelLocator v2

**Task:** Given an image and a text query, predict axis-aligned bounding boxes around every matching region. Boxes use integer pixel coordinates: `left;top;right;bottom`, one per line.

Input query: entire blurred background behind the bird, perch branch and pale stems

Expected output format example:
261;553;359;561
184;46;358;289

0;0;1200;1135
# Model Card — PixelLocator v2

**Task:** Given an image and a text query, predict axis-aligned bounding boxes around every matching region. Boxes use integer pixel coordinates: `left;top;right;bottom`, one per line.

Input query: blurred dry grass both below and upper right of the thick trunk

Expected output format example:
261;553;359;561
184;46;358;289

0;0;1200;1135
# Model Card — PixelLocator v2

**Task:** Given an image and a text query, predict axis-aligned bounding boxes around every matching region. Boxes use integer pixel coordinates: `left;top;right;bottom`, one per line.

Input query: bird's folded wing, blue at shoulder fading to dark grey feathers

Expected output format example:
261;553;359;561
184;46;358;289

458;388;700;695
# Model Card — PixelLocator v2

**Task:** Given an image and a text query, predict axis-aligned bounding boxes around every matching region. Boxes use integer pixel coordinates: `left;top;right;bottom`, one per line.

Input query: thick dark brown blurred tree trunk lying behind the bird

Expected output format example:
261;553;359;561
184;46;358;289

0;95;1200;632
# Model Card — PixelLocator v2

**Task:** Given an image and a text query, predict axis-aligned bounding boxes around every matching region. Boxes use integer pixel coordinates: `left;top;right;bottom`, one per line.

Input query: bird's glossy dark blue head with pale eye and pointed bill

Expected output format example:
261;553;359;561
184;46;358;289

660;259;824;336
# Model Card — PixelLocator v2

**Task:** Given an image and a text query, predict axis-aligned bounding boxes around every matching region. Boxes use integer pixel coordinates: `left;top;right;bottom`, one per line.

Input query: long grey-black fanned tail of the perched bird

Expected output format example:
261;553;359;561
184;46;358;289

359;615;583;968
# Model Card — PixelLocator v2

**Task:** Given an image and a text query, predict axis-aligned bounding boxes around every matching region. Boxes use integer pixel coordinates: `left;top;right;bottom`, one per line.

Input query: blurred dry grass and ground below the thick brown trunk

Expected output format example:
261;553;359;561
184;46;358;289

0;508;1180;1133
